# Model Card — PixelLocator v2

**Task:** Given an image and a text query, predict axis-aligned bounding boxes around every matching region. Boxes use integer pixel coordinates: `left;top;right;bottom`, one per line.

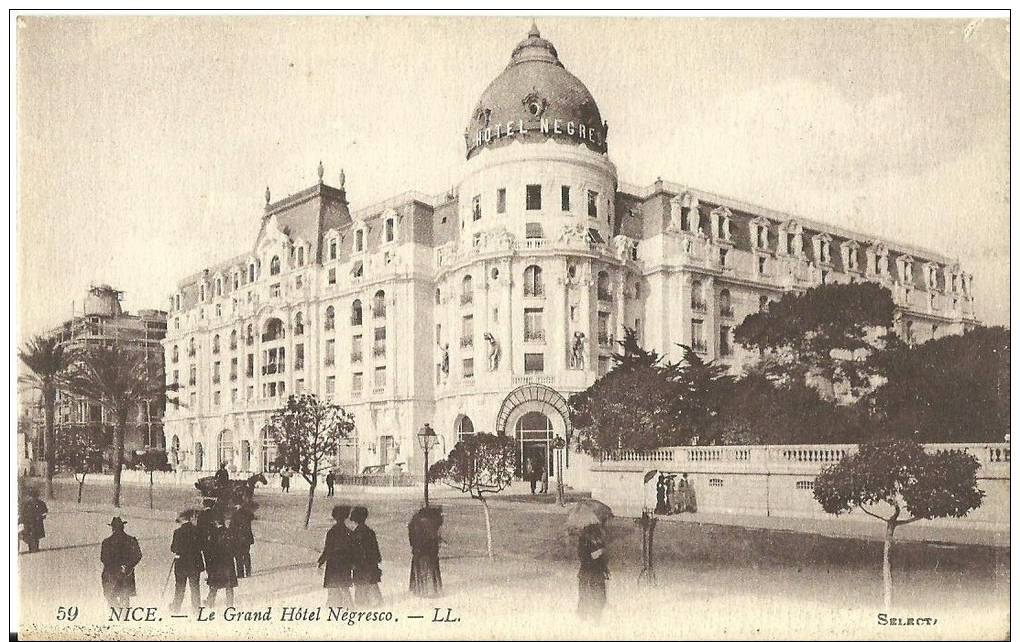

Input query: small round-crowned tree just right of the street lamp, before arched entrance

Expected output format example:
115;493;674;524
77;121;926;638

428;433;517;559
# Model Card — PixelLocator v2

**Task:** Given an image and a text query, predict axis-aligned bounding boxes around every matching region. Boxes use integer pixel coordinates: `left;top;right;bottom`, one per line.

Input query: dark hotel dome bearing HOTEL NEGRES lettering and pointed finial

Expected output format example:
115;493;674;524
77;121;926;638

464;24;608;158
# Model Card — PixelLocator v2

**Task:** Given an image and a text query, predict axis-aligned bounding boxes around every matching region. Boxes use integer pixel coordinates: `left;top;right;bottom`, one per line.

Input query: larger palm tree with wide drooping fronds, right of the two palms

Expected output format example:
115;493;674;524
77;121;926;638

67;344;177;507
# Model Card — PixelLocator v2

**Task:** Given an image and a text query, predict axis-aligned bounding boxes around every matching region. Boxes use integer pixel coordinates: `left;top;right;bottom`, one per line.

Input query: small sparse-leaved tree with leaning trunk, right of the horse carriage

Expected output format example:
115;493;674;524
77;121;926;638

266;395;354;529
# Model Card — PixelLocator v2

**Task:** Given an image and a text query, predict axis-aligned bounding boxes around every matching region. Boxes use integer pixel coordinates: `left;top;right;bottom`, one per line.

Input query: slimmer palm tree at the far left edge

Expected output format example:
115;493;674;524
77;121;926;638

17;337;74;499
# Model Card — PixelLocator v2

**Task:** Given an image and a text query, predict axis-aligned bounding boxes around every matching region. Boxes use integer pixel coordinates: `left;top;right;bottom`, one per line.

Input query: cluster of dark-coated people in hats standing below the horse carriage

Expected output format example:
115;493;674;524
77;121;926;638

170;499;255;612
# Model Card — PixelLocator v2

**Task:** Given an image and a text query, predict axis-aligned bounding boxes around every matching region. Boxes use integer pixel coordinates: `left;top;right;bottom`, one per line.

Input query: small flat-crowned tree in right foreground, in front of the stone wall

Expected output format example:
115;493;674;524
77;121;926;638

814;440;984;610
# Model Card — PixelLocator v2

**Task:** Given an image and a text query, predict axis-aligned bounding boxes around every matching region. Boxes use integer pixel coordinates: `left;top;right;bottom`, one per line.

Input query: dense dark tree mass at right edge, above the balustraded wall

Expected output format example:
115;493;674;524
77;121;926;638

870;327;1010;443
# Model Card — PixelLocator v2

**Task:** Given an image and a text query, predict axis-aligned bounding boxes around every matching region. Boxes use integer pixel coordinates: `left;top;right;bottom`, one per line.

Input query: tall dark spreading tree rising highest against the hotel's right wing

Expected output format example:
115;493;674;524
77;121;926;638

733;283;896;393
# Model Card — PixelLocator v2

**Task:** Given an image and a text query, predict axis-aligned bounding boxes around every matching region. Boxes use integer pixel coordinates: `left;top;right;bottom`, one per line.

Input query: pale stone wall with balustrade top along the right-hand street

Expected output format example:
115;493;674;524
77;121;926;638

577;443;1010;530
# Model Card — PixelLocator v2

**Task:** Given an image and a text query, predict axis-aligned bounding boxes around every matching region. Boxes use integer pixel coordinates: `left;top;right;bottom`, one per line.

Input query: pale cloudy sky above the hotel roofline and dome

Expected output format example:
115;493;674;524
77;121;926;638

15;15;1010;340
